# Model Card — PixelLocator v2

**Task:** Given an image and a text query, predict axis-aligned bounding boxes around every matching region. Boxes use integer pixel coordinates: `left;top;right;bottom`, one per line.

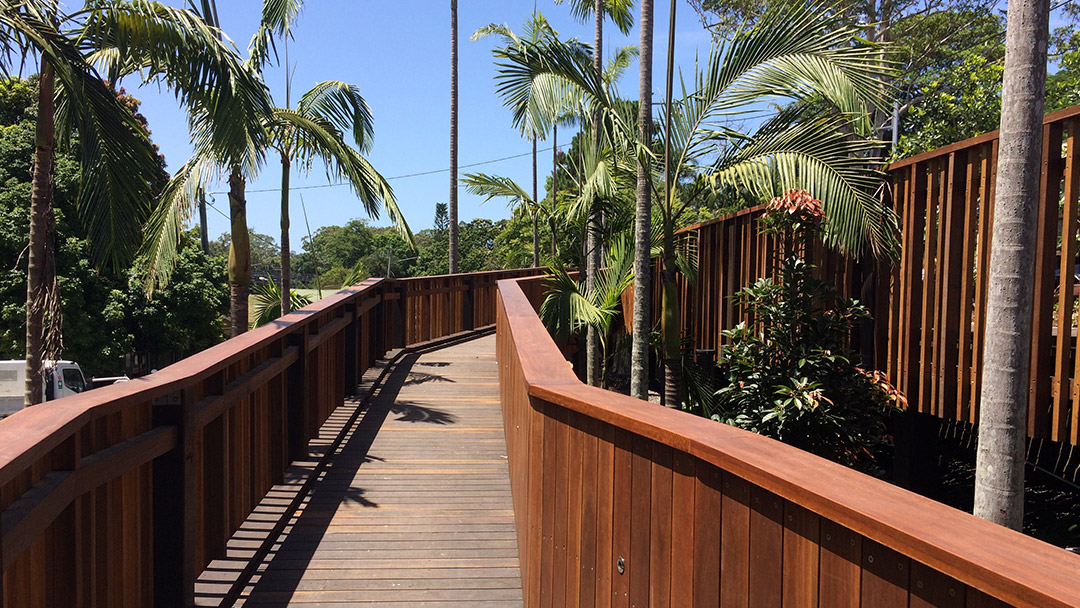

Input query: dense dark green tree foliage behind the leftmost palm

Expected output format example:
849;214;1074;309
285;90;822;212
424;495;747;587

0;79;229;376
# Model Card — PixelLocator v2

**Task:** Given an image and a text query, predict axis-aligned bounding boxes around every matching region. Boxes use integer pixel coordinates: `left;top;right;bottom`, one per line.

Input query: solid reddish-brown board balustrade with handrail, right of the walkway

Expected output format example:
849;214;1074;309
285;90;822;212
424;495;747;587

496;279;1080;608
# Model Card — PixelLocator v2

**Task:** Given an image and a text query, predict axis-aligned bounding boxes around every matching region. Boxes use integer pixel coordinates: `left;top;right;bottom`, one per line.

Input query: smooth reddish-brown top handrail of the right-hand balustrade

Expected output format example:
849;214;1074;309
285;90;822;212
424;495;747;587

499;280;1080;607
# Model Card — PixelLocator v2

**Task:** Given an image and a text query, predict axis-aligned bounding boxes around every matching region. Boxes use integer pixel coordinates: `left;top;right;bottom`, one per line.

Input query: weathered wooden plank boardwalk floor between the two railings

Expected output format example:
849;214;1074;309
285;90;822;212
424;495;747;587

197;336;523;608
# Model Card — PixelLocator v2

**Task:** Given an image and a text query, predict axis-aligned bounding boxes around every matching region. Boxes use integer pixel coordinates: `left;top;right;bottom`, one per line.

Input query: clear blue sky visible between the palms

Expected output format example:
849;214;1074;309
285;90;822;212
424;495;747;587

105;0;711;245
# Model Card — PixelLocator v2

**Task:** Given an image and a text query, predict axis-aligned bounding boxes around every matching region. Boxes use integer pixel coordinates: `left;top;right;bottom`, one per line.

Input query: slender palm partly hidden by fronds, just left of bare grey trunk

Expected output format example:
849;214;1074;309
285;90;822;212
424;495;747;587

556;0;634;386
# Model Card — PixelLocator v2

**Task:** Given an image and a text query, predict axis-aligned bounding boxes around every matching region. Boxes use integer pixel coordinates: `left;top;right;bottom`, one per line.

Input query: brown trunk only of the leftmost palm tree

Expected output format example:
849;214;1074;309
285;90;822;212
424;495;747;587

23;60;56;406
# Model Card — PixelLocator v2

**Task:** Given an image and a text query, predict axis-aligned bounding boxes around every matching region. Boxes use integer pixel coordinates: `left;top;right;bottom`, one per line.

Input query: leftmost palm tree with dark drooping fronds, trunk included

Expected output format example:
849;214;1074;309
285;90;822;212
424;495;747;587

6;0;272;405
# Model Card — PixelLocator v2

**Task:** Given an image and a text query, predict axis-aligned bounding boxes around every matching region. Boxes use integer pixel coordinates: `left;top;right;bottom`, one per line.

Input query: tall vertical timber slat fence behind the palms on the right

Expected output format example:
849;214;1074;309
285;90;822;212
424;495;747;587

669;106;1080;445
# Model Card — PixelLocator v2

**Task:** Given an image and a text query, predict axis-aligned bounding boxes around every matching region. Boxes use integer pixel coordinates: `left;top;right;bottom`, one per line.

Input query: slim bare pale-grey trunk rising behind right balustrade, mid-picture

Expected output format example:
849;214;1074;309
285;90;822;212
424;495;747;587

630;0;652;400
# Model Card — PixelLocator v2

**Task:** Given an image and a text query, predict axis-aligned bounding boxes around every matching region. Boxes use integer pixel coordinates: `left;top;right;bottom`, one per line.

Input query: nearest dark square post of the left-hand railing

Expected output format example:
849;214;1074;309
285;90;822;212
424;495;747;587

153;389;195;608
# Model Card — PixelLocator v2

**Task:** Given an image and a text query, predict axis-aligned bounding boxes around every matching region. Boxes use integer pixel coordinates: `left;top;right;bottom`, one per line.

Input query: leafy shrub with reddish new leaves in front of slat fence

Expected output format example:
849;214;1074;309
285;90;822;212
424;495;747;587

705;191;906;472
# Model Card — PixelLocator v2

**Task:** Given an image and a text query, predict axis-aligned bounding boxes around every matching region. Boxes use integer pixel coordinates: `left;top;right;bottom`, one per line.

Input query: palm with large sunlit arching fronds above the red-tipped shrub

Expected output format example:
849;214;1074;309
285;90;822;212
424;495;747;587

538;8;895;403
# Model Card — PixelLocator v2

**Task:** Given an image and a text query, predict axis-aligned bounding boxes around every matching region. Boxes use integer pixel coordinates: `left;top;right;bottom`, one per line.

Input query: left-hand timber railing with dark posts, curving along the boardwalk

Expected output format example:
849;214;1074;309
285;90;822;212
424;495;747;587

0;270;540;608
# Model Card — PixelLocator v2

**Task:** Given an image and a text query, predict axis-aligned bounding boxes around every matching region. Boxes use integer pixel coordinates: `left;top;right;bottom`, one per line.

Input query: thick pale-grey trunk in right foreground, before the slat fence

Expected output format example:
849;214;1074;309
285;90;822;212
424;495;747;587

975;0;1050;530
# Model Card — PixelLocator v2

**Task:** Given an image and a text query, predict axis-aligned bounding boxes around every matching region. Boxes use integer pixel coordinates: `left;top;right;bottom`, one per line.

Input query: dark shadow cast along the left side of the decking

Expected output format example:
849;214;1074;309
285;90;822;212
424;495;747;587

195;345;456;607
